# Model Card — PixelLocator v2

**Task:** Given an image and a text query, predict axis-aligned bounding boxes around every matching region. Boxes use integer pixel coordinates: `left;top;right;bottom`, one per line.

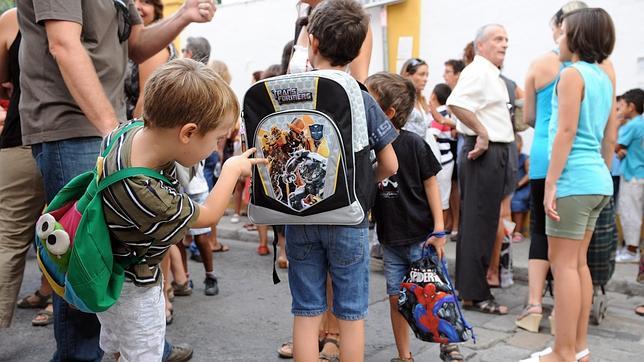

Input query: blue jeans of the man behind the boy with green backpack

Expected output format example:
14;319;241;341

31;137;103;362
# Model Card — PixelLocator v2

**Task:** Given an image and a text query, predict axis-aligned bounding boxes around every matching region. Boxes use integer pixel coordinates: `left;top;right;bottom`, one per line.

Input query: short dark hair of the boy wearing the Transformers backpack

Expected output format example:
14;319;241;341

307;0;369;67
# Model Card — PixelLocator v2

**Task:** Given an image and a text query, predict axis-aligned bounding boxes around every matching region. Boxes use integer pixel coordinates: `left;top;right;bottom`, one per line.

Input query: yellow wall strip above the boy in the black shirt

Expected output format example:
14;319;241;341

387;0;421;73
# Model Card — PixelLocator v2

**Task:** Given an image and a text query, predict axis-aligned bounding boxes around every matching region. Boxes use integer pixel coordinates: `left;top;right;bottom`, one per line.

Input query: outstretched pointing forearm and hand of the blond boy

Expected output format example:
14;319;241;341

192;148;268;228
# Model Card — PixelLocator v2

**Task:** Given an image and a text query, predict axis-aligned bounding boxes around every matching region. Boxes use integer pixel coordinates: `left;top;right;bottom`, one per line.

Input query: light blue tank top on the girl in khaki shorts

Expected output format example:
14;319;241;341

548;61;613;197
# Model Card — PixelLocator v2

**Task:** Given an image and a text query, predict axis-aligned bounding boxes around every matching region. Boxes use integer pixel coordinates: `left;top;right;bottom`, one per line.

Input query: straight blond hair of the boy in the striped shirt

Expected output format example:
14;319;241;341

143;59;239;134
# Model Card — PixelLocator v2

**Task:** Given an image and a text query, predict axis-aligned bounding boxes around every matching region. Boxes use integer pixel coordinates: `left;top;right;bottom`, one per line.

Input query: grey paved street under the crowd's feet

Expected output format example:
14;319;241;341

0;215;644;362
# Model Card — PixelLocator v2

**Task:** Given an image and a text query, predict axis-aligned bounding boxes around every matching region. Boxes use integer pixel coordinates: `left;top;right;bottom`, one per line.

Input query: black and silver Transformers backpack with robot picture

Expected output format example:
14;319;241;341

242;70;375;225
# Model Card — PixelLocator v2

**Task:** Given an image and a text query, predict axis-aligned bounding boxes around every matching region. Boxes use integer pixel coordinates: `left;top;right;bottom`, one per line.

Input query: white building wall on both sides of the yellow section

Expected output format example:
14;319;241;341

181;0;644;111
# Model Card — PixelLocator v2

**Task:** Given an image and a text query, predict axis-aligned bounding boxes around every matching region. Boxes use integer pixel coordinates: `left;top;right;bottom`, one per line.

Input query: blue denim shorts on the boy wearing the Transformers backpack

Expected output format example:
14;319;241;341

286;225;369;320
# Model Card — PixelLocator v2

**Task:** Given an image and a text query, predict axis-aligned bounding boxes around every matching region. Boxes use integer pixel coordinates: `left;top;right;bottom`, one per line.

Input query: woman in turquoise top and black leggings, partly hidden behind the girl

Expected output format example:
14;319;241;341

515;1;587;333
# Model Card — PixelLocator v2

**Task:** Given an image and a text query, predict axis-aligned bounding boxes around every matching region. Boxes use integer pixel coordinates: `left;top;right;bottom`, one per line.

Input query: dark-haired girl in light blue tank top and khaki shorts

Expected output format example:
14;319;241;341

525;8;617;362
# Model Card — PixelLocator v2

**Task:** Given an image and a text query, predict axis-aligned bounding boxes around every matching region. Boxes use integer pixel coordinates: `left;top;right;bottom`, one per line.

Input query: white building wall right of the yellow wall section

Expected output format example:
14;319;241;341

420;0;644;94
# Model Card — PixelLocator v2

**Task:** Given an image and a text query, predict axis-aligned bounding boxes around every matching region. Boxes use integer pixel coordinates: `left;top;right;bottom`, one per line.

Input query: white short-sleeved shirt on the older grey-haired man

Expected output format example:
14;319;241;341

447;55;514;143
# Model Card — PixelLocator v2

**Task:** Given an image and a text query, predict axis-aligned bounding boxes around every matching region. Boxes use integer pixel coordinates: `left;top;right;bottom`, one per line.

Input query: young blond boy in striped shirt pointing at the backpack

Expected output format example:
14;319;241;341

97;59;264;361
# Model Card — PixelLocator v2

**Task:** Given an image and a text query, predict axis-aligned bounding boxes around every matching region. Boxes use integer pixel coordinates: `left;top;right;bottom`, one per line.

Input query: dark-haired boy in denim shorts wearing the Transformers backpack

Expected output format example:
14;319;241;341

286;0;398;362
